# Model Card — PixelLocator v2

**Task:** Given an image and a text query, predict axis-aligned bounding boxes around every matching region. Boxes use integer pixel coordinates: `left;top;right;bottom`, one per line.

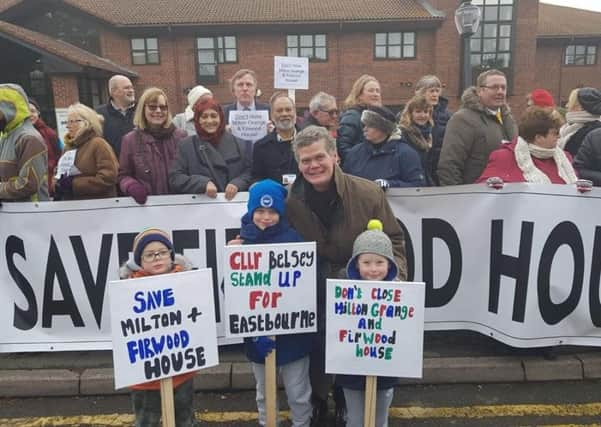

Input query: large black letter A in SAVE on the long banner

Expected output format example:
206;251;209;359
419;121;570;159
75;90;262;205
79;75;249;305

42;236;85;328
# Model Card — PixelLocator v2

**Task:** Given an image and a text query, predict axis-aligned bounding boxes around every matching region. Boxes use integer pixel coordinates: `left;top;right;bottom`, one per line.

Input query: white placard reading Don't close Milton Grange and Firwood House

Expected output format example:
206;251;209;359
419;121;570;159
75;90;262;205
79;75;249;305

326;279;425;378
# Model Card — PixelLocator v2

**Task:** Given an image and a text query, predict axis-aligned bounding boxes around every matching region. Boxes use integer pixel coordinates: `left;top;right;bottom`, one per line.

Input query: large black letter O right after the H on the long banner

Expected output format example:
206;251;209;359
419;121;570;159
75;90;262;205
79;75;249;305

537;221;584;325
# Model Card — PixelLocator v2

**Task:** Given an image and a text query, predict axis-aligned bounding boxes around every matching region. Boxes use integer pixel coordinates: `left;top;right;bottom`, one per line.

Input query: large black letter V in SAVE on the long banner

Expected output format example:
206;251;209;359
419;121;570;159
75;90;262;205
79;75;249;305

69;234;113;328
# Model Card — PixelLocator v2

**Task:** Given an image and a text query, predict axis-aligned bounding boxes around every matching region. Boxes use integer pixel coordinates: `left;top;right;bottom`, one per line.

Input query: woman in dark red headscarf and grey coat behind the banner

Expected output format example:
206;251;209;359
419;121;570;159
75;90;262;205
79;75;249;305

169;98;252;200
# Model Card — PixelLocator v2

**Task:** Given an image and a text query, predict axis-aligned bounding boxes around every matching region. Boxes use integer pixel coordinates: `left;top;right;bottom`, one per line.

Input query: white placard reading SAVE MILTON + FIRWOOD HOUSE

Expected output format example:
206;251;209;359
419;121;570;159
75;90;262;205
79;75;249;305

109;269;219;389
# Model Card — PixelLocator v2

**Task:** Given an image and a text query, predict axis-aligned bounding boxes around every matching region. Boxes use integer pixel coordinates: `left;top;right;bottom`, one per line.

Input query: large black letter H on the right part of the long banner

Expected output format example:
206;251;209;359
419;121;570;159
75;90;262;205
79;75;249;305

488;219;534;323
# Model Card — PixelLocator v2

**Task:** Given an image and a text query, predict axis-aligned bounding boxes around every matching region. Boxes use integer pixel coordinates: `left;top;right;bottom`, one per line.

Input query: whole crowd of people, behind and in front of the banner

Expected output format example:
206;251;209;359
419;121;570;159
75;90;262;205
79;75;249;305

0;69;601;427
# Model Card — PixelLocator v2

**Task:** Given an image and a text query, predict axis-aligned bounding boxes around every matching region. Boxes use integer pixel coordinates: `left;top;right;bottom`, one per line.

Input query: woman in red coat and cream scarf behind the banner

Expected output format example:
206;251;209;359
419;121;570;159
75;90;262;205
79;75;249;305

477;107;578;184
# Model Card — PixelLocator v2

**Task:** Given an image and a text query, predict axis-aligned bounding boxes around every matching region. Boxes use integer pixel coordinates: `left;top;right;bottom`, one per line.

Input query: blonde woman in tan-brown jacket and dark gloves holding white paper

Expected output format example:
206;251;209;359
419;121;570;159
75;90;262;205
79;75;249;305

54;103;119;200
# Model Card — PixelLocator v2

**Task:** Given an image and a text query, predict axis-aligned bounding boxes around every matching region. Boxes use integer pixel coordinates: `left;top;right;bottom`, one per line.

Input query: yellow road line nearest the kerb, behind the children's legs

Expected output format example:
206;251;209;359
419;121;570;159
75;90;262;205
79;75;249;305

0;402;601;427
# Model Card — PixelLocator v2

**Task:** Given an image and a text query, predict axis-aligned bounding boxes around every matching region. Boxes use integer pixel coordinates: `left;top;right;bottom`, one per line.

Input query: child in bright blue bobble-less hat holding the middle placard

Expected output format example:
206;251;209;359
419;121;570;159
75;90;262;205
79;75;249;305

234;179;312;427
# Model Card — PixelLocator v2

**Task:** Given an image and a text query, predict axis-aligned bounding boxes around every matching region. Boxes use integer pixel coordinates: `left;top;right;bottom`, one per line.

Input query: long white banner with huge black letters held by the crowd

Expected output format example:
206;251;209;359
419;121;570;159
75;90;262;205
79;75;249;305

0;184;601;352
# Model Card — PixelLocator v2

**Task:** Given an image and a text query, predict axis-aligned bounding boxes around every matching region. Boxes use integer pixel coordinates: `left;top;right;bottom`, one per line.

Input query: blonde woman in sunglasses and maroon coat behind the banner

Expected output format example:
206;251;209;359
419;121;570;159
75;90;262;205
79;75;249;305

119;87;186;205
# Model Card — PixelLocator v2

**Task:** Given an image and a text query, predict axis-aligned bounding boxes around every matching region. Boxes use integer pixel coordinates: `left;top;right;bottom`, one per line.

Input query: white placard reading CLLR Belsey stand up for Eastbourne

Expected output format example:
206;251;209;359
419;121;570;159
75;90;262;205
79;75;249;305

224;242;317;338
